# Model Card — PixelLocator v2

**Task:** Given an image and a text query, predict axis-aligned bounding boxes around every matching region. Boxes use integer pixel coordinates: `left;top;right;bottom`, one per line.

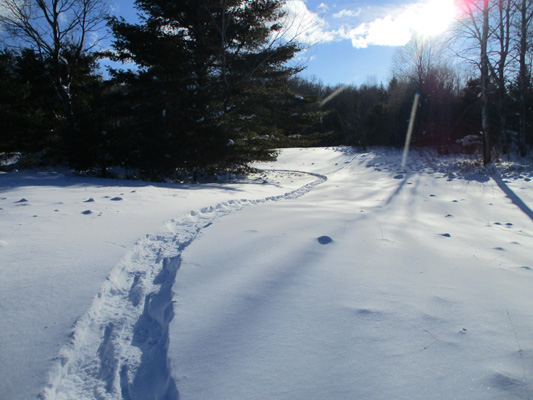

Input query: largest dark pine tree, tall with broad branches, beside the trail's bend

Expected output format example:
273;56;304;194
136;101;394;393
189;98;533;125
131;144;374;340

110;0;300;177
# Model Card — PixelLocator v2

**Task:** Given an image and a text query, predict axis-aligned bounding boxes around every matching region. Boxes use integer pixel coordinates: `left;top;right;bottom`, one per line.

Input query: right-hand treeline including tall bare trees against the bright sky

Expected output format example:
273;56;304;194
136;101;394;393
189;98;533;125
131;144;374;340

293;13;533;159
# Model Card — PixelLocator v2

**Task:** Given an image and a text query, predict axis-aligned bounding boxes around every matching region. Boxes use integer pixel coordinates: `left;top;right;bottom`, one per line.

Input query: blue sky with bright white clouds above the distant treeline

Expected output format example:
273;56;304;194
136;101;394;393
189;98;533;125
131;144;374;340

111;0;454;85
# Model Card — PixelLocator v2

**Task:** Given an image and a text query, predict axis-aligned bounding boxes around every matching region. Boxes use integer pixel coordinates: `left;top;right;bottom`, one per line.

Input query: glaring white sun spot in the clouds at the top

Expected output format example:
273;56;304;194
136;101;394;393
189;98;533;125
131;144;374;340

409;0;456;36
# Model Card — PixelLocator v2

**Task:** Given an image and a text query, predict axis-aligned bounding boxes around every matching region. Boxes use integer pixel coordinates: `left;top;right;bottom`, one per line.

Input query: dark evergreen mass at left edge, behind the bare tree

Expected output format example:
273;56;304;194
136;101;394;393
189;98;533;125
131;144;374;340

0;45;107;170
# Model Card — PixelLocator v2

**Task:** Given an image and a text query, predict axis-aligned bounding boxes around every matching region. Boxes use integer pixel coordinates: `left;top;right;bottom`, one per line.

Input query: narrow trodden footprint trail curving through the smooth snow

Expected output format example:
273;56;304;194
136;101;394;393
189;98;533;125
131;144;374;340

41;173;327;400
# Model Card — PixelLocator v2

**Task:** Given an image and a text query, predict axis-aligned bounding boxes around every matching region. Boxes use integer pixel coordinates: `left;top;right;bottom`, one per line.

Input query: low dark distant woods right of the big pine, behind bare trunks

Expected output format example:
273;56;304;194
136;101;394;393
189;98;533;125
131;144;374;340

292;67;533;155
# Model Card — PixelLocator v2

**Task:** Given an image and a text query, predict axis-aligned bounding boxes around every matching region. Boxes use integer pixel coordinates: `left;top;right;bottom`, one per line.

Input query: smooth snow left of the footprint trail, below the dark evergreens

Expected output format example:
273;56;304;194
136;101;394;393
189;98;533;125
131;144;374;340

0;164;320;400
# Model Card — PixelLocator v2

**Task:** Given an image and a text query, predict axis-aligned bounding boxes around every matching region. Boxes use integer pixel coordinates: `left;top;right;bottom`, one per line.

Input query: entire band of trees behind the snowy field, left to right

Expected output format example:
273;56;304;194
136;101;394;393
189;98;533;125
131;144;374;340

0;0;533;180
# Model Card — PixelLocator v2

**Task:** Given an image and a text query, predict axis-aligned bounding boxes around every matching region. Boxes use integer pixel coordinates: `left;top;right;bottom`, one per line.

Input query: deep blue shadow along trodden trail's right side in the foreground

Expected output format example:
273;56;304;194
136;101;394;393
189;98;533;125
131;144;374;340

120;256;181;400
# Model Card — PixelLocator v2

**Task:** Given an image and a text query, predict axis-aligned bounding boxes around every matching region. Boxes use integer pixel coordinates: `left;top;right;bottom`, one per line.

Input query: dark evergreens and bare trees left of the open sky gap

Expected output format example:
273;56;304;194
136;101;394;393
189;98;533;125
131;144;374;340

0;0;319;179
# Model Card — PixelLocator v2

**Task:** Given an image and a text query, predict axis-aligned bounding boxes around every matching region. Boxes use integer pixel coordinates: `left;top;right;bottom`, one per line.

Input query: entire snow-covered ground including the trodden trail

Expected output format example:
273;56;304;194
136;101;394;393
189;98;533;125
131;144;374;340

0;148;533;400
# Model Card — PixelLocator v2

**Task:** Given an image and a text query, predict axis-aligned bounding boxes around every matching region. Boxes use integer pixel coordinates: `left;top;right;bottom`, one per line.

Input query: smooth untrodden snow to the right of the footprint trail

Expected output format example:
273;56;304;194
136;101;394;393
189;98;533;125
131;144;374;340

169;151;533;400
